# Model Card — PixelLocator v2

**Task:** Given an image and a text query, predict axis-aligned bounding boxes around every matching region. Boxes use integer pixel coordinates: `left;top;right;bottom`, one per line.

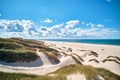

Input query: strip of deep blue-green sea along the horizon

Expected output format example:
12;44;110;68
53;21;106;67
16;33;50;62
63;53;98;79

45;39;120;46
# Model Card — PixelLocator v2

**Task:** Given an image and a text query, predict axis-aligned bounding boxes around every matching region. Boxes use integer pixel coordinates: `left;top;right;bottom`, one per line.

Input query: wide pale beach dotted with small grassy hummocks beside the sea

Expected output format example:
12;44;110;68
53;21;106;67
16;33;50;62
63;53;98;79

46;41;120;75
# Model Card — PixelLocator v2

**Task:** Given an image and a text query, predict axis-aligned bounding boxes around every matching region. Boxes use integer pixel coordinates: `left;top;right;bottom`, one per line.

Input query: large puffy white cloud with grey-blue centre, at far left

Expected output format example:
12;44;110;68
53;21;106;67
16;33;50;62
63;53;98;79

0;20;34;32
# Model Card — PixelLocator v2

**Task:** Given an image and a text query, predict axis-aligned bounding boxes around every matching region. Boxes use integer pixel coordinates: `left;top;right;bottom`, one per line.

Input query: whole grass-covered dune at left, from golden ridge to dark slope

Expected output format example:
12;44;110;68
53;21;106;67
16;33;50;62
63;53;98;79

0;38;44;62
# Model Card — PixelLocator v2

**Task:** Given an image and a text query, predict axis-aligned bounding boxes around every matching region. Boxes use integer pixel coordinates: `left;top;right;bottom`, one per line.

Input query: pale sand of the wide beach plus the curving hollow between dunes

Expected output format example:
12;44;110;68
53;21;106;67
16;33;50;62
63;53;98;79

0;41;120;75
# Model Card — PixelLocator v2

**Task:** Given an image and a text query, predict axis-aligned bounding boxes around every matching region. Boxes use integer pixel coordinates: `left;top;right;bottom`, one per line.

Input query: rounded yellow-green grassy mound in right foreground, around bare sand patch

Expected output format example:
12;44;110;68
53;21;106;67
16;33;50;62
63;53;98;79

52;64;120;80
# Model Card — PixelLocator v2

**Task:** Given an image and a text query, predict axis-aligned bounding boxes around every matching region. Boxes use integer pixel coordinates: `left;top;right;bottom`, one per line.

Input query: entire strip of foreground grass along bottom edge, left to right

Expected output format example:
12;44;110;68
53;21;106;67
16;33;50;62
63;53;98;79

0;64;120;80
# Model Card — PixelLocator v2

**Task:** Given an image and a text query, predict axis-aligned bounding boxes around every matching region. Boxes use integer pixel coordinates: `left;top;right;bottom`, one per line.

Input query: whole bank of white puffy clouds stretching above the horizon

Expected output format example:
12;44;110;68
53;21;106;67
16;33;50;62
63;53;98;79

0;20;120;38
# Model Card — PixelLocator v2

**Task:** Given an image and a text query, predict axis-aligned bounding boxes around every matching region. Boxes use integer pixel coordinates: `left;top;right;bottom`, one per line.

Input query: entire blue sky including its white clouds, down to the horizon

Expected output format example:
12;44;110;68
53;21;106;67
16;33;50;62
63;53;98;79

0;0;120;39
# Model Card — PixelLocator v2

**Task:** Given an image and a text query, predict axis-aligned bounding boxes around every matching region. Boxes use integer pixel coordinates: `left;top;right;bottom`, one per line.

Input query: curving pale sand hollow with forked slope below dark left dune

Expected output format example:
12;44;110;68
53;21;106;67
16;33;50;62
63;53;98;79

0;49;75;75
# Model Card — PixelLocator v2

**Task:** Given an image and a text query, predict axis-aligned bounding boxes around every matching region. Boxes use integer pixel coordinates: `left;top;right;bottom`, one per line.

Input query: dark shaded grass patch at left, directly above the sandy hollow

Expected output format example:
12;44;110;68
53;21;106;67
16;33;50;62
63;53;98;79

0;49;39;62
